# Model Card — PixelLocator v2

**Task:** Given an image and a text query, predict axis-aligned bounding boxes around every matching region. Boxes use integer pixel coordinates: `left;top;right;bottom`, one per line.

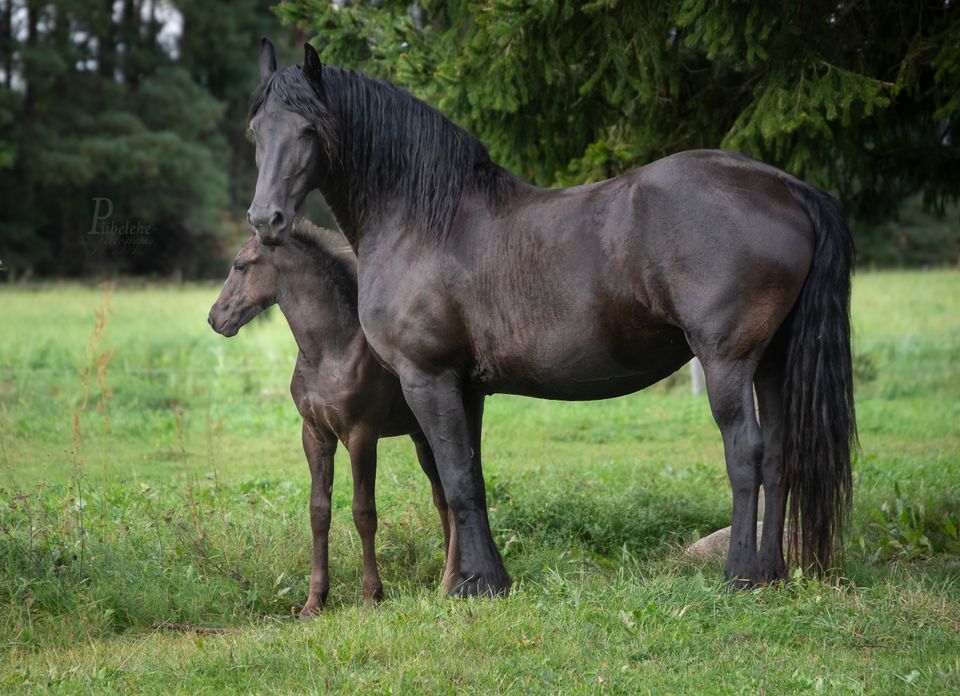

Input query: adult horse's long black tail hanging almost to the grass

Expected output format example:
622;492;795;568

783;181;858;572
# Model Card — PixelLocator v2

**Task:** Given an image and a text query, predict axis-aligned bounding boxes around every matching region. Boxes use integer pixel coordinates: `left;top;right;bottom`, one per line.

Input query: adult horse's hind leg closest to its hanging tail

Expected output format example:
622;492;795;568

754;346;787;582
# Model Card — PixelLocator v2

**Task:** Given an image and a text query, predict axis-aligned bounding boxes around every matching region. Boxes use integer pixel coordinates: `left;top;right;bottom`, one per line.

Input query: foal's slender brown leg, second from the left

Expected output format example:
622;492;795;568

347;431;383;605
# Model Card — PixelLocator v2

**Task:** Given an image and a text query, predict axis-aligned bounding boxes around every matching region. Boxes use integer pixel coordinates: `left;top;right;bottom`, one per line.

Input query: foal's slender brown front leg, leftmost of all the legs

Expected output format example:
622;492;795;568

300;421;337;619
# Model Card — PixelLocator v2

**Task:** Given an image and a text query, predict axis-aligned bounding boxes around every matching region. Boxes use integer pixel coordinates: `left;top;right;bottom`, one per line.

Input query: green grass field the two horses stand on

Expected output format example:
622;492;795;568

0;271;960;694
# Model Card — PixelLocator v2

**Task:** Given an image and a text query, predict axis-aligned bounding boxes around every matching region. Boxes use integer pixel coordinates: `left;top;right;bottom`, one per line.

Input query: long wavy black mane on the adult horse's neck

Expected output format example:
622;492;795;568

250;65;517;239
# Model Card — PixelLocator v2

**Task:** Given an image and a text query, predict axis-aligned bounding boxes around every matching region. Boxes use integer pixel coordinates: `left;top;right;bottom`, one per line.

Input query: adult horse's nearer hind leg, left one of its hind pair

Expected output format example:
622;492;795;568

703;358;763;587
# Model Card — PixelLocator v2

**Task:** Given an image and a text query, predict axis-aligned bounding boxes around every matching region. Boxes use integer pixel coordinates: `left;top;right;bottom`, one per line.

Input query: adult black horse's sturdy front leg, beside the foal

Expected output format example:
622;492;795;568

400;371;510;596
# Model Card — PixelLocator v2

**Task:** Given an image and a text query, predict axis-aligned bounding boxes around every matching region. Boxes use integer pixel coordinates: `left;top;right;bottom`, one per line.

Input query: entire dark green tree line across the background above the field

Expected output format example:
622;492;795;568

0;0;960;274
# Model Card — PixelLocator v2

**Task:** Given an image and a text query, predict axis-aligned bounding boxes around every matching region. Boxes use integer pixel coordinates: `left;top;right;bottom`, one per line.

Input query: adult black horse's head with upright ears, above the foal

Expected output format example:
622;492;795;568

247;39;322;245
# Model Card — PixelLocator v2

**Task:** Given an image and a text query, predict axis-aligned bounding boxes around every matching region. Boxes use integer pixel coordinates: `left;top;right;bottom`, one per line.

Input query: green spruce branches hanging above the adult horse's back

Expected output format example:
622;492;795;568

277;0;960;234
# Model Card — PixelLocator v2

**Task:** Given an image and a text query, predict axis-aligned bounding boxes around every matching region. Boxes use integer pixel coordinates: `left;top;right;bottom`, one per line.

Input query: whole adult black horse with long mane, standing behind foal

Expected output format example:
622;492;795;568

248;40;856;595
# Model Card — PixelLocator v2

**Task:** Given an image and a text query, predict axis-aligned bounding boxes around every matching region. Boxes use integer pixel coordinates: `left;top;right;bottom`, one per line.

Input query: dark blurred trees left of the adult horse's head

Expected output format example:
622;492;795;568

0;0;304;278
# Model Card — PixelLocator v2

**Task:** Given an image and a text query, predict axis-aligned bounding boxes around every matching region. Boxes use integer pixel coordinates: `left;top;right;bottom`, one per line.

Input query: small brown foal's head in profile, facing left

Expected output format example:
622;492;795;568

207;237;280;338
